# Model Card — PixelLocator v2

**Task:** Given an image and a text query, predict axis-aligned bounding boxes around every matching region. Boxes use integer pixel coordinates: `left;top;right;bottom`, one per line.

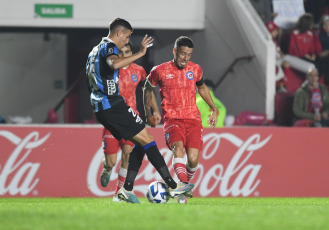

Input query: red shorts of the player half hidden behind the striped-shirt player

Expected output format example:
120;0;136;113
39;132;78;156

103;128;134;155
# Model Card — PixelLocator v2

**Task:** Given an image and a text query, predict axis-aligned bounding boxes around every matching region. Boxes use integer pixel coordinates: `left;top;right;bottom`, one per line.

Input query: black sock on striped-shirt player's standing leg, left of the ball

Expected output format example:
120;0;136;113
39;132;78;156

123;145;145;191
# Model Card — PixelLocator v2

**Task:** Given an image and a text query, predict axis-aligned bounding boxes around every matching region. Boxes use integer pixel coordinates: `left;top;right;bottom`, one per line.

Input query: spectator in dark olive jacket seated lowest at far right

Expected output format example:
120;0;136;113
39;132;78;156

293;69;329;127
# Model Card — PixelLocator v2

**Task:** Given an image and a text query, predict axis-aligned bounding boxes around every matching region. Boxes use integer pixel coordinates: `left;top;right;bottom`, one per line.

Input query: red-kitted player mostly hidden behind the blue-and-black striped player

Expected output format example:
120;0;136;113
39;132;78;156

100;43;160;201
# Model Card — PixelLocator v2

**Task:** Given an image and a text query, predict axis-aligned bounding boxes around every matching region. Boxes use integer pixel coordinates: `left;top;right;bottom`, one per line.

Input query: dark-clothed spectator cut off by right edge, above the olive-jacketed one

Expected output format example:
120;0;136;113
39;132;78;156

319;15;329;86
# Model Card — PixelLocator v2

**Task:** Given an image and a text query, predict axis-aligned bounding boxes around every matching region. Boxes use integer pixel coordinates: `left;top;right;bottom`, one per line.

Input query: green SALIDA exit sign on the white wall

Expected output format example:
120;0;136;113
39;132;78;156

34;4;73;18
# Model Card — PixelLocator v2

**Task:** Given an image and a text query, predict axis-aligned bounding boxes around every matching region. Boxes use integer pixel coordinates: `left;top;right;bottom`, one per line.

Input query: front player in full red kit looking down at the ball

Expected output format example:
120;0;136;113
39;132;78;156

144;36;218;197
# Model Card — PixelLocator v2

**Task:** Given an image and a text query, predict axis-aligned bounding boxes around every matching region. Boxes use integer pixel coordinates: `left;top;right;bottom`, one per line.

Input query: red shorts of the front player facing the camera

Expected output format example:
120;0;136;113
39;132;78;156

163;119;203;151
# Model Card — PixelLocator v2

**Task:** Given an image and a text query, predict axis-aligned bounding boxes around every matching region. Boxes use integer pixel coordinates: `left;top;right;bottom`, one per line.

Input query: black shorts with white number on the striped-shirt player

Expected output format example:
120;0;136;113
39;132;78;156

95;101;145;140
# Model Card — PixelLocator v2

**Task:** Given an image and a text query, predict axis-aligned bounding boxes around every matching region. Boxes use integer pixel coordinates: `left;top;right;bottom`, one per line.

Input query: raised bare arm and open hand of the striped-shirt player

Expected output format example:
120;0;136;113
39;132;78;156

106;34;153;69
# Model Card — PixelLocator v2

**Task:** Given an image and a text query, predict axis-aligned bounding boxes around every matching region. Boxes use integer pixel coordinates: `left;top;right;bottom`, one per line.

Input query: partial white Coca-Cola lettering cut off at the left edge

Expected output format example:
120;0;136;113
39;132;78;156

0;130;50;196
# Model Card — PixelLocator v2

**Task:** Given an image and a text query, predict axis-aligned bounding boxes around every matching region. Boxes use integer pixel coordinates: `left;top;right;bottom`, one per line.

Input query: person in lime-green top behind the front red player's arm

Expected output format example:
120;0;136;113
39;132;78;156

196;79;226;128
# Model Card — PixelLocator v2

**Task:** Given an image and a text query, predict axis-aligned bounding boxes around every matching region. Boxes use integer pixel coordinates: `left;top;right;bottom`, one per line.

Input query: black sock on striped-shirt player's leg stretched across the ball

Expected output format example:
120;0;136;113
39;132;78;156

143;141;177;188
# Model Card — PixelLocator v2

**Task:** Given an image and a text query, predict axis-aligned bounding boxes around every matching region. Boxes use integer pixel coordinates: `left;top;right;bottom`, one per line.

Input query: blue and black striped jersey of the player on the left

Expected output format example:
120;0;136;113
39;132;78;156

86;37;124;112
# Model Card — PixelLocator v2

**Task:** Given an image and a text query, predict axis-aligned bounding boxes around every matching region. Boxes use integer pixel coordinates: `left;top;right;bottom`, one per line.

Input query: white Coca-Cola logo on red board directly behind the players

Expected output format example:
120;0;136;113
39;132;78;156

87;133;272;197
